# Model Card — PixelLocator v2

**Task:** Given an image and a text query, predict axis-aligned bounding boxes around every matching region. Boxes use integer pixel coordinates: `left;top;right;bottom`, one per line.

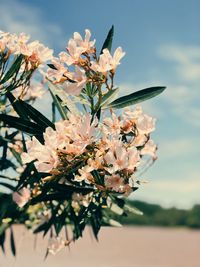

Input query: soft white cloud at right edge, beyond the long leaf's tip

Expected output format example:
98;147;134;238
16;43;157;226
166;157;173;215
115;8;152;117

158;44;200;127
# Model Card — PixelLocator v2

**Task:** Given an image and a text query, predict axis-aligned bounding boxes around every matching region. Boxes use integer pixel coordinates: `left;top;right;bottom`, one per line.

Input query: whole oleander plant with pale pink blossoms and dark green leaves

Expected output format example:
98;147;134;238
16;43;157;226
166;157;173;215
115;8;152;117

0;27;165;254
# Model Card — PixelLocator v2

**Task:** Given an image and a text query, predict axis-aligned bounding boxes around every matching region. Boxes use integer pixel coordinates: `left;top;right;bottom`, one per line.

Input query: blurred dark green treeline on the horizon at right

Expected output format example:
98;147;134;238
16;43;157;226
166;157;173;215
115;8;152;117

109;201;200;228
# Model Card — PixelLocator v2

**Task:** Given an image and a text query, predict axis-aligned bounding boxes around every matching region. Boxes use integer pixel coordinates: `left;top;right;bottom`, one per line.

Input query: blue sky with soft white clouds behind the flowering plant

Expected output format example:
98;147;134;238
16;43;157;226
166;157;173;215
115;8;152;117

0;0;200;207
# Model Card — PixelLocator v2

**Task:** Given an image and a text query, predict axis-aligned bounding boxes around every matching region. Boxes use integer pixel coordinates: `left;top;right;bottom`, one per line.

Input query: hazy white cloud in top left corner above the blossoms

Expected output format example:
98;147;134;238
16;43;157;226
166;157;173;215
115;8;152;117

0;0;66;48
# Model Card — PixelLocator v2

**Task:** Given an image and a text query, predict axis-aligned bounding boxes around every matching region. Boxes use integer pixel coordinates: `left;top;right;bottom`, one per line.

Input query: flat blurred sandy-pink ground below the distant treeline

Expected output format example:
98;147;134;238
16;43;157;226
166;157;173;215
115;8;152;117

0;227;200;267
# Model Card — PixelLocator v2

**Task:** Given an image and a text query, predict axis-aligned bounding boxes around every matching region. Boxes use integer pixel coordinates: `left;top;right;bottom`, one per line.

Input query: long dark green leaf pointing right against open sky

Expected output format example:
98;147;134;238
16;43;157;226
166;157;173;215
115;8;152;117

105;86;166;109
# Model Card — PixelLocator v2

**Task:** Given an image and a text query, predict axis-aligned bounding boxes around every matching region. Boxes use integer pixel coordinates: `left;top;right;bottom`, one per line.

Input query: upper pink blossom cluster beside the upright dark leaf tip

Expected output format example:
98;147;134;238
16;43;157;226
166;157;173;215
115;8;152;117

47;29;125;95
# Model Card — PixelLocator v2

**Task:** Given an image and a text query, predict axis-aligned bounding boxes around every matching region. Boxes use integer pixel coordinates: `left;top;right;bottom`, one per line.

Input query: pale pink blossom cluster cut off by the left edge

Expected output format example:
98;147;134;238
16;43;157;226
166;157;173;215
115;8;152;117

0;31;53;100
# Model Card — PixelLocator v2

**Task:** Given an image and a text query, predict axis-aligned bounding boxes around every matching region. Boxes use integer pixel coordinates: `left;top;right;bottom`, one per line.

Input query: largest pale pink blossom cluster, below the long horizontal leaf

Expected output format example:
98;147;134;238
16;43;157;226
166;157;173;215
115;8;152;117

22;107;157;195
